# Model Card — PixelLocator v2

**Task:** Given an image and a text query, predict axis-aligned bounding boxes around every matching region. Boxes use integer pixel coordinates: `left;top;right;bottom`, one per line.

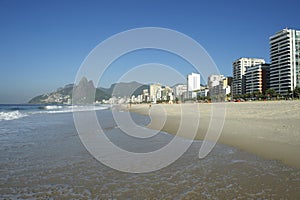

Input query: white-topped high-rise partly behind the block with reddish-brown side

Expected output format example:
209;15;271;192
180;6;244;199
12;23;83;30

232;58;265;95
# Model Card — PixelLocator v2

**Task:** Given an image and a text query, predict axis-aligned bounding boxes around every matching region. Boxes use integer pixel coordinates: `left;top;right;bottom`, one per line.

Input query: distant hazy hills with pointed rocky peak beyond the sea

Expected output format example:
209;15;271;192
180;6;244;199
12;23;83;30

28;77;149;104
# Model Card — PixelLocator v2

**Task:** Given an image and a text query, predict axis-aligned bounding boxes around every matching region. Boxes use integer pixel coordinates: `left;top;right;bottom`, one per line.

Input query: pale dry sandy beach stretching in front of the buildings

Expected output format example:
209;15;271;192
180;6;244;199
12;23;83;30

129;101;300;168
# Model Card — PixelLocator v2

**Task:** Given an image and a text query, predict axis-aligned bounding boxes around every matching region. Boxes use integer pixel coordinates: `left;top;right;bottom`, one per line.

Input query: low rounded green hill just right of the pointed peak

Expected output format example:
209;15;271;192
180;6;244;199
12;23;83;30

99;81;149;97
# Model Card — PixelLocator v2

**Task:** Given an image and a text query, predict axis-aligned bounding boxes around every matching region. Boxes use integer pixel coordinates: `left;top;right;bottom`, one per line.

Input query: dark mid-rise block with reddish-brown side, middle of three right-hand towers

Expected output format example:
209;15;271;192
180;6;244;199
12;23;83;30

245;64;270;94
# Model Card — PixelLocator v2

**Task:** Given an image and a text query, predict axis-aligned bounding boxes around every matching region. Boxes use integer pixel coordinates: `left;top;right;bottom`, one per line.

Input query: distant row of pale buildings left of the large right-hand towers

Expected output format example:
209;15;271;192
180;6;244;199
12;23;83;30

104;73;232;104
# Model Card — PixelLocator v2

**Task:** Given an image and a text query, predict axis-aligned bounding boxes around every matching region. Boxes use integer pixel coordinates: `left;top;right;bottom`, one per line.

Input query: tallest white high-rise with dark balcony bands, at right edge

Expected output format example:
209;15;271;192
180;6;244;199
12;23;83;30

269;29;300;95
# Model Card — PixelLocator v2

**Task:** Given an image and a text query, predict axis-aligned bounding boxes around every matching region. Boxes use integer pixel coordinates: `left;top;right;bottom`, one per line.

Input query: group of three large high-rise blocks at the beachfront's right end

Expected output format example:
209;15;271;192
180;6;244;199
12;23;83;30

232;29;300;96
